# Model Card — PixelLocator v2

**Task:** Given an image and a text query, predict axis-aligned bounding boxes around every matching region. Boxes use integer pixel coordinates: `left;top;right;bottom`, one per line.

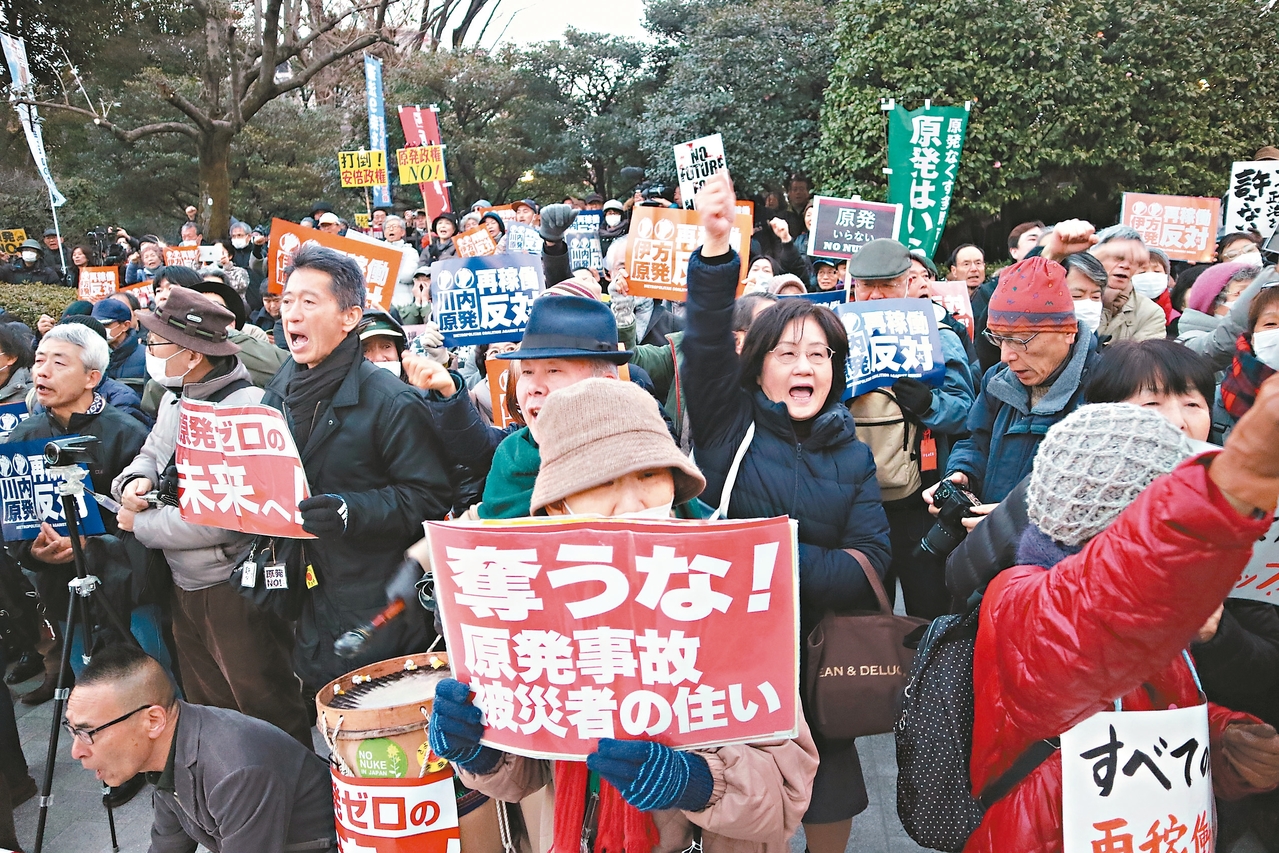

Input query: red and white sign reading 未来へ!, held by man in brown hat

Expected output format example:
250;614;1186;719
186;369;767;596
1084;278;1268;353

174;398;315;538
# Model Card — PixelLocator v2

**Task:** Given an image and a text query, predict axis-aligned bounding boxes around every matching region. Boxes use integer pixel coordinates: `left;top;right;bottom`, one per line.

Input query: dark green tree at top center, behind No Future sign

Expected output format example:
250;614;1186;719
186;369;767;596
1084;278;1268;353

640;0;836;194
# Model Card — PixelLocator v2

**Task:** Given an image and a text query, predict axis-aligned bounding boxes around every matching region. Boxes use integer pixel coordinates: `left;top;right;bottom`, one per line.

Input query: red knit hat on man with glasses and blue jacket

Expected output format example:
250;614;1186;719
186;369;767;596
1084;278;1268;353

986;256;1079;335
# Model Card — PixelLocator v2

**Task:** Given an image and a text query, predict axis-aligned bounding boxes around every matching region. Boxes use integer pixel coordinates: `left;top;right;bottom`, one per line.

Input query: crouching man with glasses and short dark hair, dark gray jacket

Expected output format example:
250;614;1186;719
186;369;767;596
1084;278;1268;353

63;645;338;853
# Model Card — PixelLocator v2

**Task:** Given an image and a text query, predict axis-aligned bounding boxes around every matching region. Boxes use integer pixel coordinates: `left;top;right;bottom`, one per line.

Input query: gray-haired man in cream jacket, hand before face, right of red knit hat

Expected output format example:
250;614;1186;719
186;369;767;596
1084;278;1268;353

1088;225;1168;343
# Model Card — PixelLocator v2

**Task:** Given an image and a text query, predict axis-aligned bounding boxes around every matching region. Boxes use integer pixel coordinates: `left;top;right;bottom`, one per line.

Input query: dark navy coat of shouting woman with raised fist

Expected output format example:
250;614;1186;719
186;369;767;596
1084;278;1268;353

679;252;890;630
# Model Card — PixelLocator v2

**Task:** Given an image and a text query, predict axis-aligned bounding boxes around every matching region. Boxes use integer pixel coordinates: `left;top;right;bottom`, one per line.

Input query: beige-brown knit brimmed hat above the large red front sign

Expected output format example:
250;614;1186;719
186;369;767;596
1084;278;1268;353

531;379;706;514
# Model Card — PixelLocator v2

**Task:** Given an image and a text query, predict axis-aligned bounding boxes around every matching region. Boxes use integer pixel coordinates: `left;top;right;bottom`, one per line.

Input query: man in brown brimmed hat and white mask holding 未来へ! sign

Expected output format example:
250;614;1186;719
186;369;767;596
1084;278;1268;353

111;285;311;747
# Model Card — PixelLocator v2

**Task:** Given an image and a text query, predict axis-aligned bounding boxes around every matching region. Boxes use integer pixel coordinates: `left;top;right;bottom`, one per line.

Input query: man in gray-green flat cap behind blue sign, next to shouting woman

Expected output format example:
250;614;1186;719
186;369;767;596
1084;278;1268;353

848;239;973;619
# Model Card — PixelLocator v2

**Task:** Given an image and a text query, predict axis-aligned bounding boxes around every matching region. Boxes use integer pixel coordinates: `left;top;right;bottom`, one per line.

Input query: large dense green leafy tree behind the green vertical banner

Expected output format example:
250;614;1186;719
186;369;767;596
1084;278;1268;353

810;0;1279;256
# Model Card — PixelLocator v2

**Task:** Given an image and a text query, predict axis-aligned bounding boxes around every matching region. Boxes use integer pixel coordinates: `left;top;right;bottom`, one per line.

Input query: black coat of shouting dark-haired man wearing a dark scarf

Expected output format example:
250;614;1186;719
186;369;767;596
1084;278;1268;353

262;347;453;689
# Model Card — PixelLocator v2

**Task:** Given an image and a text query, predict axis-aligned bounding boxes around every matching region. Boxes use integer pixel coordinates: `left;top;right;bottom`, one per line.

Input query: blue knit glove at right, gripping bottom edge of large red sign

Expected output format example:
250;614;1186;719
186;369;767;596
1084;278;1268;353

585;736;715;812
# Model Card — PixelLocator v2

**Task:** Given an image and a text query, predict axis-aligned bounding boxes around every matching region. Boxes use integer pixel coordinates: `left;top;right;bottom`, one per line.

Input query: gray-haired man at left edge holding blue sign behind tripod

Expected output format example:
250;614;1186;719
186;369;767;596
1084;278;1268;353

8;324;147;705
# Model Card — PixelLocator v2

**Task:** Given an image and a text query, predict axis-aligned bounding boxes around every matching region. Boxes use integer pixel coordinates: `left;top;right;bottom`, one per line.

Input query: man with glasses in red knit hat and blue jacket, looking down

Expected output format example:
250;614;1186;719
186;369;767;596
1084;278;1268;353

923;256;1097;514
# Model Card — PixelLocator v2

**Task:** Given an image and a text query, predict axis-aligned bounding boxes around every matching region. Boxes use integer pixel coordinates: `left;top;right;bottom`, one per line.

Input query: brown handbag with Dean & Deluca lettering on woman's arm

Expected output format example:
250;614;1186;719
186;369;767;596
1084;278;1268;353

804;551;930;740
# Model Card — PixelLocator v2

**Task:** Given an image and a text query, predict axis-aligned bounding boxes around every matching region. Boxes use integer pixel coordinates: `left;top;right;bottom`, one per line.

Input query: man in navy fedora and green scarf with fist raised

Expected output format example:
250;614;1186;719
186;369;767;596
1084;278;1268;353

404;294;632;518
